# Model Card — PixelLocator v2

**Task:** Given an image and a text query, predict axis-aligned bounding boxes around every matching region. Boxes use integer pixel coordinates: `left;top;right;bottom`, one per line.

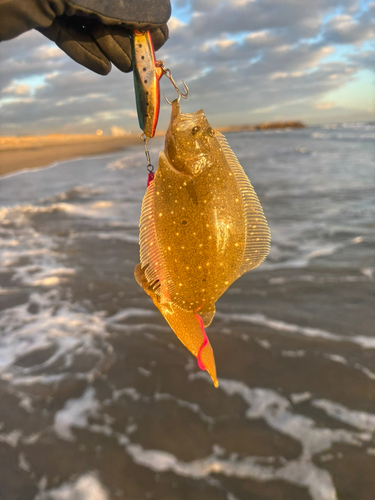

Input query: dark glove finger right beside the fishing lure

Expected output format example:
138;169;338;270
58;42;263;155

90;23;132;73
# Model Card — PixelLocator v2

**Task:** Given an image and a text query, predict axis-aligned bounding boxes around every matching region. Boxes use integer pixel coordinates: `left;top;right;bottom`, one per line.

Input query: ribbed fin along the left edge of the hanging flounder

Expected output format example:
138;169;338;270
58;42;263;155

140;181;172;303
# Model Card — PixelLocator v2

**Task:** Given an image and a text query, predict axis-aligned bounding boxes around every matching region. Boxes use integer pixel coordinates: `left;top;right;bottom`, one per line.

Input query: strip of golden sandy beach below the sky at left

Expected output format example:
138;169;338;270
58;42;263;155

0;134;140;175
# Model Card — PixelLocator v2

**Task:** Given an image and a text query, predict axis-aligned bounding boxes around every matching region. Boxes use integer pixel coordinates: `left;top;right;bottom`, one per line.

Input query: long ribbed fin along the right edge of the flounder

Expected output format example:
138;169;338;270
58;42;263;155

216;132;271;277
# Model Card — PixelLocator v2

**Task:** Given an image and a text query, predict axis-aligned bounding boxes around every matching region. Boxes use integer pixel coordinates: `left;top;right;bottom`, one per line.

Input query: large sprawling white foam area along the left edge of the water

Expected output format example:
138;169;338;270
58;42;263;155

0;203;120;384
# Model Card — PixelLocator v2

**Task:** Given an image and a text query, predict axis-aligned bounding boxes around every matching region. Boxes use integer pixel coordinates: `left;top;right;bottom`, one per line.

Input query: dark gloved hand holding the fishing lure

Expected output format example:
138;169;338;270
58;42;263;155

0;0;171;75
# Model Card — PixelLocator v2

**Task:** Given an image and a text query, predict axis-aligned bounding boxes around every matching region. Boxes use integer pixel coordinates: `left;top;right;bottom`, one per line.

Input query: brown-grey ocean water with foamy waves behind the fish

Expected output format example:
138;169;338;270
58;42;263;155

0;123;375;500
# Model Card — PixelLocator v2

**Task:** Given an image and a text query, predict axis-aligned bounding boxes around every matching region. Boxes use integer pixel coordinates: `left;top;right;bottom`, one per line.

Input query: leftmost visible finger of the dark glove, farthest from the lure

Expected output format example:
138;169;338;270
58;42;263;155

38;16;111;75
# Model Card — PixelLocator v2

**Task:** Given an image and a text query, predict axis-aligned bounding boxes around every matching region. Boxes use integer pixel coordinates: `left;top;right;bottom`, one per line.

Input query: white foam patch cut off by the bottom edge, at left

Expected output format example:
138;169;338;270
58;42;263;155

35;472;110;500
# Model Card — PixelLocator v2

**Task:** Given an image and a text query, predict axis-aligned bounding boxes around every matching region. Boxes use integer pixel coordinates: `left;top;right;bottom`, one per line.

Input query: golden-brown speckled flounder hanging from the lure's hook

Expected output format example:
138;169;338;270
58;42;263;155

135;100;270;387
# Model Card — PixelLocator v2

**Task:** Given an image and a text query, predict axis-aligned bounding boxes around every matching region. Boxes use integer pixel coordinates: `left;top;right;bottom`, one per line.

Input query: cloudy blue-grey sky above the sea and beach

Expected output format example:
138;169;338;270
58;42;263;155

0;0;375;135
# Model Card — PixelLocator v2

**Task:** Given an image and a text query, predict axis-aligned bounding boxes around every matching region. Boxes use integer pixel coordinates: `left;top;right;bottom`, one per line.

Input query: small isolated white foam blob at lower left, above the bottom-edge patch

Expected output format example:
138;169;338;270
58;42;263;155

53;387;99;441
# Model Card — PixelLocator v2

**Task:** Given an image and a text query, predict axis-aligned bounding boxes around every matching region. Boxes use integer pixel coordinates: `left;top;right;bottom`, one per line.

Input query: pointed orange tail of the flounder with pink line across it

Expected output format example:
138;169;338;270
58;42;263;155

160;304;219;387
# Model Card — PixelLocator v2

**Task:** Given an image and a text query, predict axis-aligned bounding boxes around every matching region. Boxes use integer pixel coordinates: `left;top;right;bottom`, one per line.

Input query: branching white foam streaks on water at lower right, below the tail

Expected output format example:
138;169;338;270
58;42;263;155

118;373;375;500
